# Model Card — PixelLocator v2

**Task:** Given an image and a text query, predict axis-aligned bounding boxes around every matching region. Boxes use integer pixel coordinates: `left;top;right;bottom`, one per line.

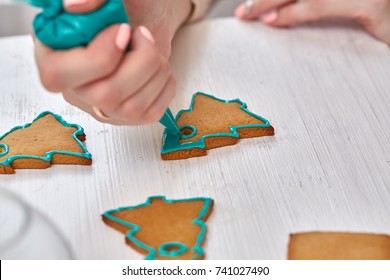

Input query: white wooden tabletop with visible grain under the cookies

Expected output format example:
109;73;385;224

0;19;390;259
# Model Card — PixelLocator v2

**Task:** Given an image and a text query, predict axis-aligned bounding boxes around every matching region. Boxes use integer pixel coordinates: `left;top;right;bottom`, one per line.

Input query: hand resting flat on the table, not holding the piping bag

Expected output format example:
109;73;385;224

235;0;390;43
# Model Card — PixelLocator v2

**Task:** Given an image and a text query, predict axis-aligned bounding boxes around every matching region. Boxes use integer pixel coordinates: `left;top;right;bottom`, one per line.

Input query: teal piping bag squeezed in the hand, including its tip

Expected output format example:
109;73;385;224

21;0;180;135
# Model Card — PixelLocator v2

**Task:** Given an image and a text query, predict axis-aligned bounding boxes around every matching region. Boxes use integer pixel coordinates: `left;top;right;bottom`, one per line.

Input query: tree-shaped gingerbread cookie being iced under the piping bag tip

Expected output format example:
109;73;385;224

161;92;274;160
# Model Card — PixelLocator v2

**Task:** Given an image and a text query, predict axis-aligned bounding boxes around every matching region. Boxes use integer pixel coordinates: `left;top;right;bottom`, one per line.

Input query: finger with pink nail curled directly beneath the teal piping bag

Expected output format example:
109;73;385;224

35;24;131;92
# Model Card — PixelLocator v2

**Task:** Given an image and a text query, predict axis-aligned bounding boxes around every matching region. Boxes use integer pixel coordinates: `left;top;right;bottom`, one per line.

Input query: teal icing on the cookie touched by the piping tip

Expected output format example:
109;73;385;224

161;92;271;154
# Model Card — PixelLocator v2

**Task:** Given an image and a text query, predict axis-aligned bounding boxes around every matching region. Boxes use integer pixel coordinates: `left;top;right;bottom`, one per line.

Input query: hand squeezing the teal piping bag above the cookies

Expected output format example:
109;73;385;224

30;0;191;128
